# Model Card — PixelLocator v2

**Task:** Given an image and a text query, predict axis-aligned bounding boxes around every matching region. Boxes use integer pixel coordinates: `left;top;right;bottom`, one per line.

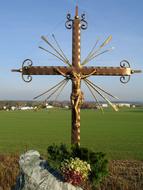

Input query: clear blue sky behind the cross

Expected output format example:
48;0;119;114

0;0;143;101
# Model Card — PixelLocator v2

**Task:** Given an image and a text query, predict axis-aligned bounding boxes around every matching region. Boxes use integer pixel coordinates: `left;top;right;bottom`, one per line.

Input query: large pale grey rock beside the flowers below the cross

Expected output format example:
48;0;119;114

15;150;82;190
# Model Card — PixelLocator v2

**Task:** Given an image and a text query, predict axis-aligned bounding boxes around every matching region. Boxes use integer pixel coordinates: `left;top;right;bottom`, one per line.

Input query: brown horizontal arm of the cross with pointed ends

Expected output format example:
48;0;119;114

12;66;136;76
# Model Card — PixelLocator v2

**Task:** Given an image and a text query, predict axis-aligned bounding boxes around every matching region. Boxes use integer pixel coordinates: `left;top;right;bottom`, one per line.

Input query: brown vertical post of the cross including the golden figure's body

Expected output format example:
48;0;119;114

71;7;83;145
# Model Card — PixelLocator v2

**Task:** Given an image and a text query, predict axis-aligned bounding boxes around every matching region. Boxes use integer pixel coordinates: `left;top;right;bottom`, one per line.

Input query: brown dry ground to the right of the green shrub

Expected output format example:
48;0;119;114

99;160;143;190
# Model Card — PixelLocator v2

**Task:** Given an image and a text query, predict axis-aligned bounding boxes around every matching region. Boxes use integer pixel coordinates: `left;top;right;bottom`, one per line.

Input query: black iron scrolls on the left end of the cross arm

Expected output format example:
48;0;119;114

22;59;33;82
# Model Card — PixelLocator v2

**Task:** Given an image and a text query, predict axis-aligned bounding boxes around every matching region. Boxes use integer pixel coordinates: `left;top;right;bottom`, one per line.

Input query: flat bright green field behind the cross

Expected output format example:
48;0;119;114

0;108;143;160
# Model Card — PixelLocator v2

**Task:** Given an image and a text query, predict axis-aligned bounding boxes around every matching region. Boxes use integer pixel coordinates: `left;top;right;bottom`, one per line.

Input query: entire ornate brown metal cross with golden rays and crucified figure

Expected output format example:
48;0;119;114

12;7;140;145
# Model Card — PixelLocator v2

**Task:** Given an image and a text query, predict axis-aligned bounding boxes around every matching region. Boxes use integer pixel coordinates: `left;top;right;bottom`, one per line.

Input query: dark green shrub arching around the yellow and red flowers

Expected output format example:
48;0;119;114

48;144;108;189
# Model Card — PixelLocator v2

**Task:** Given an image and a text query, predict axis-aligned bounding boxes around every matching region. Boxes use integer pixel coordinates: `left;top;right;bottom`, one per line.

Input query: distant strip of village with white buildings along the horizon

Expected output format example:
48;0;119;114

0;100;143;111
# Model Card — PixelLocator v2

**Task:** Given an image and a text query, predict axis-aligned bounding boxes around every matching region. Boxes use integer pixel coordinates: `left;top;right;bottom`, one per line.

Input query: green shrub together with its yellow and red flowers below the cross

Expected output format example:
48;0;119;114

47;144;108;190
